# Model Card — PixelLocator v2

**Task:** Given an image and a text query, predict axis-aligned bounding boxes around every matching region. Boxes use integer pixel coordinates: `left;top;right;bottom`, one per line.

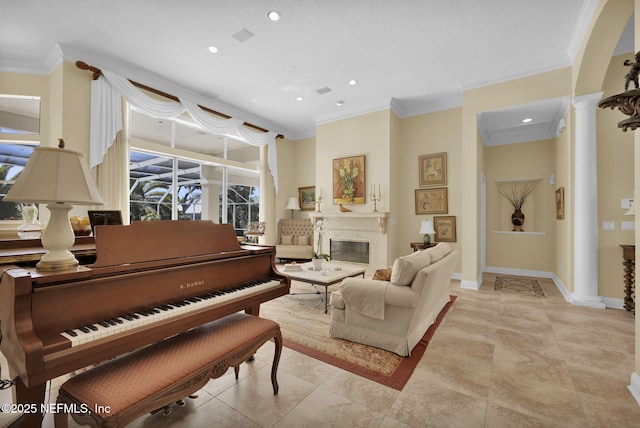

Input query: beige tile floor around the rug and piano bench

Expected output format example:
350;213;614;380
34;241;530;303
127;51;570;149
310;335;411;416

0;274;640;428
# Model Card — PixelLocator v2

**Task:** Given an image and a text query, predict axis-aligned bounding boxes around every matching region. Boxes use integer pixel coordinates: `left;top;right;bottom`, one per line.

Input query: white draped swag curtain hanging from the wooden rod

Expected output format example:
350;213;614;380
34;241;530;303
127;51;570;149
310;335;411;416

89;70;278;194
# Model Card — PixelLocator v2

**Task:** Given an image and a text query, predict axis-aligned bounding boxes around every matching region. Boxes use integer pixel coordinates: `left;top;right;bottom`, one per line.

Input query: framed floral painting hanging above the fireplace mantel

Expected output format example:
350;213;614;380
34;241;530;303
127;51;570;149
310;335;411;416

333;155;366;205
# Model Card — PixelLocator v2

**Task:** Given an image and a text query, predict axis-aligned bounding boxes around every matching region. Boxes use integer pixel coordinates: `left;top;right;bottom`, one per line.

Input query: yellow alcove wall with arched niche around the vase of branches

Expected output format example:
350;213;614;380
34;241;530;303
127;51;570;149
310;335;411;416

484;139;556;272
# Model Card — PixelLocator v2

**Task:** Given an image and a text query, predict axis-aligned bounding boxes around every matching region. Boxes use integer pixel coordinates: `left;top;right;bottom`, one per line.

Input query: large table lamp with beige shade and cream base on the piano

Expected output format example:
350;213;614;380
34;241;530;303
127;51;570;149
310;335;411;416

4;143;104;271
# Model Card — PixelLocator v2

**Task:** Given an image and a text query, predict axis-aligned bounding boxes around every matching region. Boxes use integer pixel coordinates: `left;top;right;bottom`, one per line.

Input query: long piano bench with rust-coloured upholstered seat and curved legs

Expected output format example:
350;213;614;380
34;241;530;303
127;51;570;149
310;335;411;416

54;313;282;427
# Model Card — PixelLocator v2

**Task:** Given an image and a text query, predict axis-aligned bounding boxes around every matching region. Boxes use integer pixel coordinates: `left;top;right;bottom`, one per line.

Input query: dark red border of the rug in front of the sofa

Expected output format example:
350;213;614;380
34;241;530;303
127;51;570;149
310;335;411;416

283;295;457;391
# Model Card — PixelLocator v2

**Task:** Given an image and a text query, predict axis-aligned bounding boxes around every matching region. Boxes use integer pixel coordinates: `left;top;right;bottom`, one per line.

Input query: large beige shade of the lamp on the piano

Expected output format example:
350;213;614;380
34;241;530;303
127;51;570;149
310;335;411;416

4;147;104;205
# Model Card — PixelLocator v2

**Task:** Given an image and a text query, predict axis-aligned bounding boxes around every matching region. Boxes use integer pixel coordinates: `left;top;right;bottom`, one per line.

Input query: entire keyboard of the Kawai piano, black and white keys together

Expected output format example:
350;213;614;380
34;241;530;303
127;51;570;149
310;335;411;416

60;280;280;347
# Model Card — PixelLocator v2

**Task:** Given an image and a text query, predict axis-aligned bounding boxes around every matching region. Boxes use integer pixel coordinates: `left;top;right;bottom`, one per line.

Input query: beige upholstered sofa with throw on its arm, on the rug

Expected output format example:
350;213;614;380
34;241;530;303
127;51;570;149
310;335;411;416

329;243;459;356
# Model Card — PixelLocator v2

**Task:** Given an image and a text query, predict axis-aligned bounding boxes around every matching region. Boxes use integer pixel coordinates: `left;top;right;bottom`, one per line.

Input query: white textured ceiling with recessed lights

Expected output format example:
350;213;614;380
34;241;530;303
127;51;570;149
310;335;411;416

0;0;612;139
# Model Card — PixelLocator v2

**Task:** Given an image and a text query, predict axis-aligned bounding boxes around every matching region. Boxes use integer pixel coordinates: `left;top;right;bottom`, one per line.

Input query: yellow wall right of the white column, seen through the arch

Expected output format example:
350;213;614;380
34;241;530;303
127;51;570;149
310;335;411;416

600;53;635;299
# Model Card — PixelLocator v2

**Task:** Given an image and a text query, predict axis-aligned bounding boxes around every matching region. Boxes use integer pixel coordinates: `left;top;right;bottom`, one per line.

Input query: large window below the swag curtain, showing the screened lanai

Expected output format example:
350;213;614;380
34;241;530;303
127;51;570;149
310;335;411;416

129;110;260;227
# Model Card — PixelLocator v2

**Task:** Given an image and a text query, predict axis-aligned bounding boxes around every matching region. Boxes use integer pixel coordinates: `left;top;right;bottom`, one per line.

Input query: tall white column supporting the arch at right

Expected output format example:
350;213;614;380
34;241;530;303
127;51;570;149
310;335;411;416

571;92;605;309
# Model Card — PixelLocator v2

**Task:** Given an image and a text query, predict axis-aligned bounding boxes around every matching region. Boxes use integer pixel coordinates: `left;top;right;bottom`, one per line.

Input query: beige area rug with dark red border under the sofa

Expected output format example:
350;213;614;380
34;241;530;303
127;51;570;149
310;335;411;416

260;281;455;390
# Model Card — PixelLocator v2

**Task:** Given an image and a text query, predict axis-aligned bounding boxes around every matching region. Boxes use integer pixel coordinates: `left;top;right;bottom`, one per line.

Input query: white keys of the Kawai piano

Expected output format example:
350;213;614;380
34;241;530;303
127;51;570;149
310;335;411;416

60;280;280;347
